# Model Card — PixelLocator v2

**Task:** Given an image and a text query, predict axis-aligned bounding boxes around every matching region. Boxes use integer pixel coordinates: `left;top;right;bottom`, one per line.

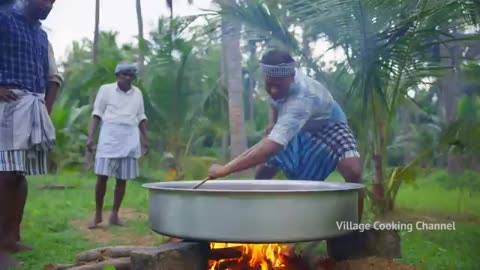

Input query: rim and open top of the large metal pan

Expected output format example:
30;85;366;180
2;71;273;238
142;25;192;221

142;180;365;193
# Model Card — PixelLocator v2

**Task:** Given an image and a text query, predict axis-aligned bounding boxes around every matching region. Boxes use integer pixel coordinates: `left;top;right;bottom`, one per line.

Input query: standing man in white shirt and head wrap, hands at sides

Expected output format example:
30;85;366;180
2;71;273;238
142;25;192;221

87;64;149;229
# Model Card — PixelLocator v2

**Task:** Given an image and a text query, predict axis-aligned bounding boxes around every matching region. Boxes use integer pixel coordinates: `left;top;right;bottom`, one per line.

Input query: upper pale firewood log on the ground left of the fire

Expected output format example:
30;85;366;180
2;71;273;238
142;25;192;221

76;246;157;262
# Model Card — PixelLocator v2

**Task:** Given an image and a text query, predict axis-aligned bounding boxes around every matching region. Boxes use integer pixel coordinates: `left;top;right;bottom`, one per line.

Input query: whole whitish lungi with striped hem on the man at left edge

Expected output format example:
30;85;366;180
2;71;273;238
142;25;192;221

0;89;55;175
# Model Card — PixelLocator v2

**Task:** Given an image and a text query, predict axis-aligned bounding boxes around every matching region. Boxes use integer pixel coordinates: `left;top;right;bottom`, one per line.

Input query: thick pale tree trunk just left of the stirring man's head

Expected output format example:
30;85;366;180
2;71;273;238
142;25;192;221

222;19;247;162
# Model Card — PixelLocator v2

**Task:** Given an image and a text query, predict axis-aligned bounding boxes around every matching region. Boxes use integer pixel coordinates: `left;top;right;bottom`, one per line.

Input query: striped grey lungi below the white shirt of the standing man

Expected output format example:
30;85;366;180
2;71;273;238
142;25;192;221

94;157;139;180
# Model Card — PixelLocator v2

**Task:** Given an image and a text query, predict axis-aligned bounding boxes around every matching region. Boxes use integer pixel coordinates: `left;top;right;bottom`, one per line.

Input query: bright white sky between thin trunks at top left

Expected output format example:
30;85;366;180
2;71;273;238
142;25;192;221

43;0;212;60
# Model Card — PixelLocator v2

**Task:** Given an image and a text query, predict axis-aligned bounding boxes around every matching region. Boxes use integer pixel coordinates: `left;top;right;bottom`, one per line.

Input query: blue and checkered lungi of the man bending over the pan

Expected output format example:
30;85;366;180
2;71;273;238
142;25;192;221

266;122;360;181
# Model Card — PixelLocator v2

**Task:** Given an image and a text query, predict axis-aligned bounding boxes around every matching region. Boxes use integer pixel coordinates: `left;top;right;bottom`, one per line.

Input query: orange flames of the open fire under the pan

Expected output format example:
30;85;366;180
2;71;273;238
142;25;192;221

209;243;288;270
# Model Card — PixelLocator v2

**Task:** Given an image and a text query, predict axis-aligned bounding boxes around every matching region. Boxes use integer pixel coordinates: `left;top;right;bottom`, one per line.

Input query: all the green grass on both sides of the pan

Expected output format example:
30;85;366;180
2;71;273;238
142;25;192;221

9;170;480;270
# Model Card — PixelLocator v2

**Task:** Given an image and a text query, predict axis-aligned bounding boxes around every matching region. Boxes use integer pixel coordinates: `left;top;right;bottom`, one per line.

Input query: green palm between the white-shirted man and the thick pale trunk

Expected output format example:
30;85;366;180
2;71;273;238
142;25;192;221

144;18;222;180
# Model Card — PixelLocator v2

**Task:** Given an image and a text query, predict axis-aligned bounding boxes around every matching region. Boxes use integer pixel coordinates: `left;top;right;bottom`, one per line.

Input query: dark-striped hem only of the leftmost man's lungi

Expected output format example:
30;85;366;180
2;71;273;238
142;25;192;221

0;150;48;175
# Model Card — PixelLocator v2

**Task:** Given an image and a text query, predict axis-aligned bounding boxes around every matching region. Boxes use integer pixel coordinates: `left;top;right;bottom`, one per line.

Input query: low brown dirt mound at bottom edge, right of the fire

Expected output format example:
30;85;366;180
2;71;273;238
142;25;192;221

335;257;417;270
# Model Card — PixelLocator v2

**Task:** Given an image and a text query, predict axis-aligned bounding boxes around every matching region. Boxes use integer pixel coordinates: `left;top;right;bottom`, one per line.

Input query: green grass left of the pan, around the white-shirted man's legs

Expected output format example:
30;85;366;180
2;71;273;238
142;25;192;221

17;173;157;270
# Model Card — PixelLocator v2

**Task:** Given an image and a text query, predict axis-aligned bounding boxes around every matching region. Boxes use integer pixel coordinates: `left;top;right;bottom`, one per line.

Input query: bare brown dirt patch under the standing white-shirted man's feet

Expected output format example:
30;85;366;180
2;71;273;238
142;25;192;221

71;208;168;246
